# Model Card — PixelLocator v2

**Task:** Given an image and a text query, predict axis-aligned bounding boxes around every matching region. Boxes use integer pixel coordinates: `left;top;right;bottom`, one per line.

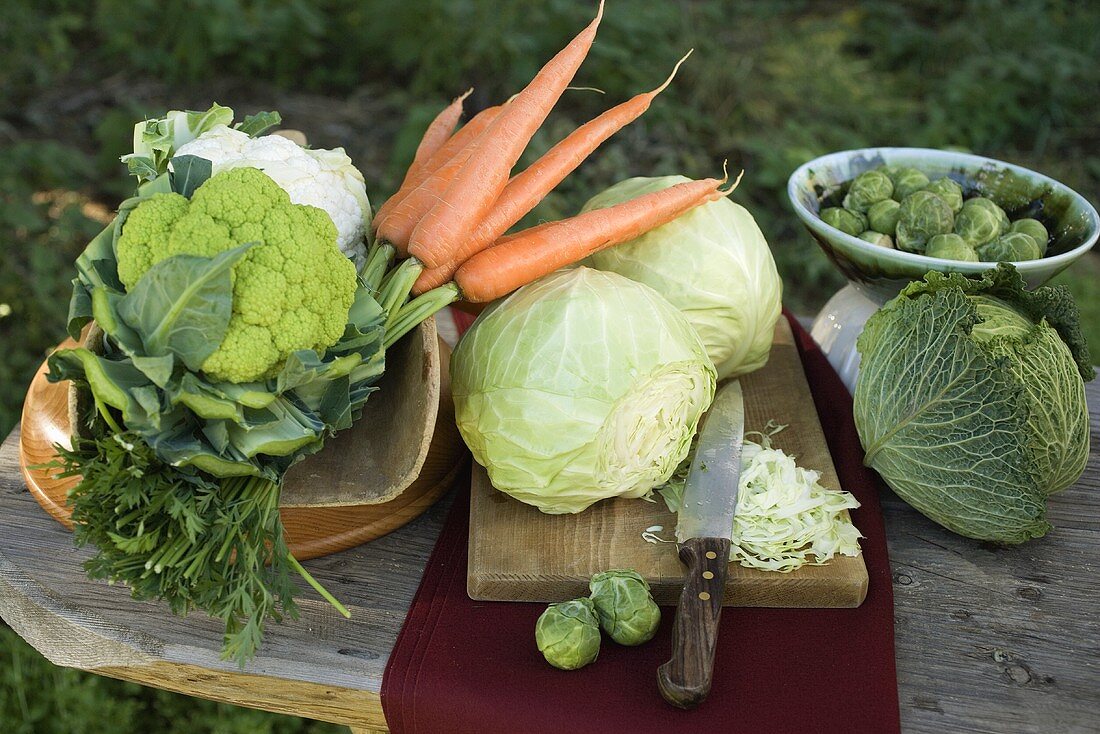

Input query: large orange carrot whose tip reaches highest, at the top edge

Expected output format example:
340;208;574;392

409;0;604;267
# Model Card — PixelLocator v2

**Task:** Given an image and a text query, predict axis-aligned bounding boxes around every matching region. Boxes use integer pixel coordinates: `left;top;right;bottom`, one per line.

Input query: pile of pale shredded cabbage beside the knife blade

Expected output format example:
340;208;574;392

658;424;862;573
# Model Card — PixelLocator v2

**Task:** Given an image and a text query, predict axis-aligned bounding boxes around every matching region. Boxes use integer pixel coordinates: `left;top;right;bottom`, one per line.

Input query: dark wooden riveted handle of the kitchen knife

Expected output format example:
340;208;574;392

657;538;729;709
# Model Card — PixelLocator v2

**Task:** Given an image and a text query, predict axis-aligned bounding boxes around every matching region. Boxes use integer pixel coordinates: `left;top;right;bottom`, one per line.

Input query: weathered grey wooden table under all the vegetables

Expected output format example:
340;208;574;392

0;380;1100;734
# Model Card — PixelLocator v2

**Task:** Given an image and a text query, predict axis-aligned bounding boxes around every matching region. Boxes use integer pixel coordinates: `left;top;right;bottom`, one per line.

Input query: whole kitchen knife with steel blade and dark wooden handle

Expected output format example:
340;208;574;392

657;380;745;709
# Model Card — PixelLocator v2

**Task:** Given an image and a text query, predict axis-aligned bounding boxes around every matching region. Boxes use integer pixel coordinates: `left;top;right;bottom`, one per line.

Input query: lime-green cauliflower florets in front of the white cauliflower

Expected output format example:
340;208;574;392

116;168;356;382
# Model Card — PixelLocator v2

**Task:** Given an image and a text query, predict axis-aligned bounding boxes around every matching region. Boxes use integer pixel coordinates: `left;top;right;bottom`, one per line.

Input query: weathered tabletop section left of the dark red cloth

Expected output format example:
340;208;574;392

0;424;451;728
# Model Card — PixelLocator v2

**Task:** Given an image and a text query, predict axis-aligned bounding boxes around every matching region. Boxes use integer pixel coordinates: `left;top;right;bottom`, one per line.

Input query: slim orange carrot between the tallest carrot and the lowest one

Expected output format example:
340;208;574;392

413;51;691;295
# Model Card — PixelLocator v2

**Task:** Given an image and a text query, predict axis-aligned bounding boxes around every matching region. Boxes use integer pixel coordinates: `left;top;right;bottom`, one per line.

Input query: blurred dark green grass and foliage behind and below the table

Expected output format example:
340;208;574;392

0;0;1100;734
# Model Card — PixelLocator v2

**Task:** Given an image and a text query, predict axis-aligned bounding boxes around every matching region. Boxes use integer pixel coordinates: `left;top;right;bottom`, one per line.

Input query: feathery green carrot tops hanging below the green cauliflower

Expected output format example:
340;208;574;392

58;433;310;666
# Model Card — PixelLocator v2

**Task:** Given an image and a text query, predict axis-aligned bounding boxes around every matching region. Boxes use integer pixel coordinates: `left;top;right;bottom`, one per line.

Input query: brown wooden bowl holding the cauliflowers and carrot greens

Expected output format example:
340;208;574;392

20;320;468;559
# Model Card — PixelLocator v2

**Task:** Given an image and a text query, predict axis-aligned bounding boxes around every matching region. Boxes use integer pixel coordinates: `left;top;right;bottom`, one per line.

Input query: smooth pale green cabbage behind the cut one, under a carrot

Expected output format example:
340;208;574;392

583;176;783;380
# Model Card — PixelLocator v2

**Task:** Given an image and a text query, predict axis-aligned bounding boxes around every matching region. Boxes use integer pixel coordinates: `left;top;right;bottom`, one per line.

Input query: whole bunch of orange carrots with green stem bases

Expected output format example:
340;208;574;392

366;0;729;341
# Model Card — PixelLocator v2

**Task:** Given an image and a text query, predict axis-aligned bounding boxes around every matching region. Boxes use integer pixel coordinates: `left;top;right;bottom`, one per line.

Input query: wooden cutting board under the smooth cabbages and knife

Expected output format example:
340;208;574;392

468;318;867;607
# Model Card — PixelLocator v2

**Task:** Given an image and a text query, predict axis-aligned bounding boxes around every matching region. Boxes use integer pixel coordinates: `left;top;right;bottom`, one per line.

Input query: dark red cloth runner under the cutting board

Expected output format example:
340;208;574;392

382;315;900;734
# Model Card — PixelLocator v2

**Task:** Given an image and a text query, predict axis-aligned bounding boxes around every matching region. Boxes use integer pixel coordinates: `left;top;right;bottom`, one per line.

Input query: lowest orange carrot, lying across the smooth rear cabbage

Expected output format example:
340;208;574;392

454;173;737;303
